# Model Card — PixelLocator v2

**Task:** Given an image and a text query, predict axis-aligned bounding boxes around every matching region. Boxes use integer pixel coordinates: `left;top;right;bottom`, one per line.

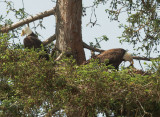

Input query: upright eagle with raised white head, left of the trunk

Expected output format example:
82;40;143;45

21;27;49;60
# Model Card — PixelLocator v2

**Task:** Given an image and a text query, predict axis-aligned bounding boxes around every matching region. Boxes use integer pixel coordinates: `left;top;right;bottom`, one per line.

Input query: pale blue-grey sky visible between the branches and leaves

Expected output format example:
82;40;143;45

0;0;151;69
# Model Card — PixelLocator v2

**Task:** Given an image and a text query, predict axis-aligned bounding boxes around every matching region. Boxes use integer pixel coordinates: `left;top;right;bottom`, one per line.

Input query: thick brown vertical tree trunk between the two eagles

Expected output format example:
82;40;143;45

56;0;86;65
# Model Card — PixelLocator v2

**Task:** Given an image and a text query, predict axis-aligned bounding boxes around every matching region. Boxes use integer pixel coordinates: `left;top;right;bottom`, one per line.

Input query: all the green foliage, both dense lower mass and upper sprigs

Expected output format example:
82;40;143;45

0;0;160;117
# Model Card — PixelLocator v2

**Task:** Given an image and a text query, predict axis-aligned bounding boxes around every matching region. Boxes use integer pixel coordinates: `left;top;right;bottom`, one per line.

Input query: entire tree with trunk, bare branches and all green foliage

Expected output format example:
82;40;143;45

0;0;160;117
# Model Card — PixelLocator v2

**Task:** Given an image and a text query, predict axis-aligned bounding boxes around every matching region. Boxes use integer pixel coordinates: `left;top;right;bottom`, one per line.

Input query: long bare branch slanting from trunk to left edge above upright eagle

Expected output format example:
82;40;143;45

0;8;56;33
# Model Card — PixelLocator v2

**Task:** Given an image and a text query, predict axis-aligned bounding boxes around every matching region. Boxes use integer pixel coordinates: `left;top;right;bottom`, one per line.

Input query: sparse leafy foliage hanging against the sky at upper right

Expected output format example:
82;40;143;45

106;0;160;56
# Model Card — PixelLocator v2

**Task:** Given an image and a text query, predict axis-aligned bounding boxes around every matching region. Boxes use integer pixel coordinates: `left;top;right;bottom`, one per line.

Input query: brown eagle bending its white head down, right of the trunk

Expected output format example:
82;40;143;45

84;48;134;70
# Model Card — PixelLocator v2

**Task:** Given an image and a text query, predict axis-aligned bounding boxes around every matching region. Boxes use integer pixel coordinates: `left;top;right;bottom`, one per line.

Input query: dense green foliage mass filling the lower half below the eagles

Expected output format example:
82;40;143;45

0;36;160;117
